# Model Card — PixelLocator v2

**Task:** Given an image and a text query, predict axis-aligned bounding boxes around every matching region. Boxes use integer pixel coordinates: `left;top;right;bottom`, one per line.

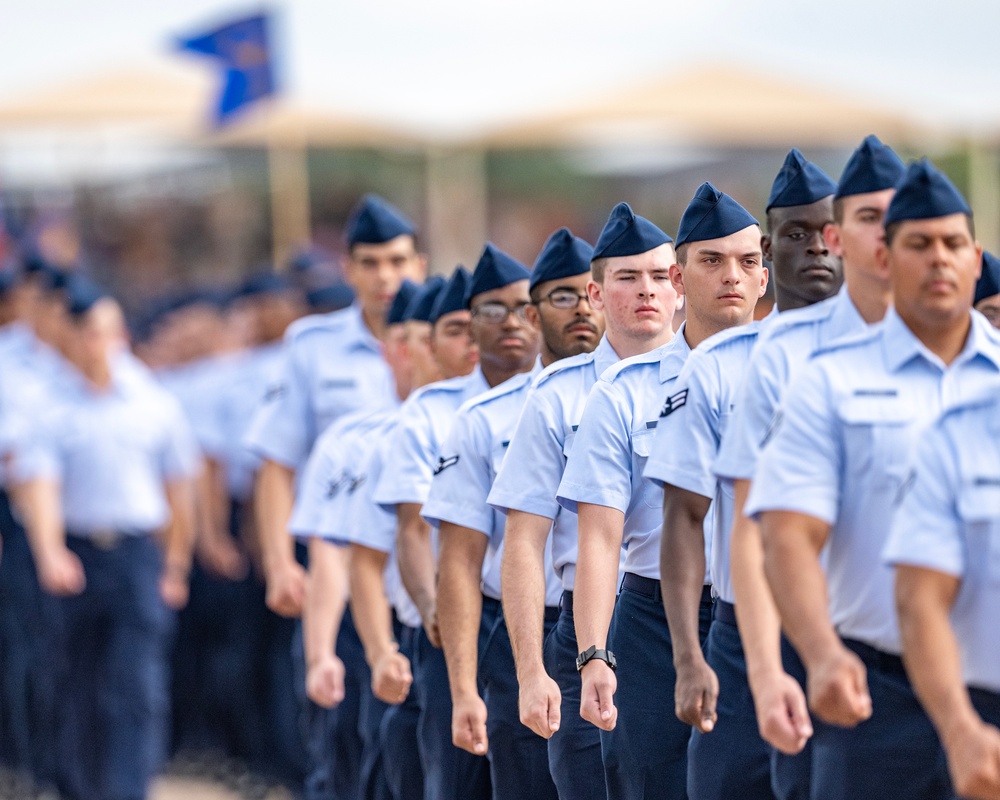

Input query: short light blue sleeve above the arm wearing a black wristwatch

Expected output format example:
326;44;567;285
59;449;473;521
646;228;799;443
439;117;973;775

558;379;632;514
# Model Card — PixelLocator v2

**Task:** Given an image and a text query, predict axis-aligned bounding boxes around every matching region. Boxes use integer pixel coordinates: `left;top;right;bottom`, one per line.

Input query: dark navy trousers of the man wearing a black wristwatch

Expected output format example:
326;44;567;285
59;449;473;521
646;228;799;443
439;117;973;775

601;573;712;800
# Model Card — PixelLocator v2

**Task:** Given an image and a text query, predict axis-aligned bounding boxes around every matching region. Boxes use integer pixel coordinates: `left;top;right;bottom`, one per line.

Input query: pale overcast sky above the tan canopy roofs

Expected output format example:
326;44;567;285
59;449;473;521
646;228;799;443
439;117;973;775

0;0;1000;137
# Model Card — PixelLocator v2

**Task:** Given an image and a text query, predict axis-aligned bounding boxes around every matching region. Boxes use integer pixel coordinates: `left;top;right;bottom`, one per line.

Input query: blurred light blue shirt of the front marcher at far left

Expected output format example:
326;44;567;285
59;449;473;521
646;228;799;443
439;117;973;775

16;360;198;535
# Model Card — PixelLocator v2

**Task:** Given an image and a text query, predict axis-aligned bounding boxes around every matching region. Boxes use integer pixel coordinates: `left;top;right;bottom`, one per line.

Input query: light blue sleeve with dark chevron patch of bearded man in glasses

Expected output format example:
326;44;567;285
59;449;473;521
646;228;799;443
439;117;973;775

421;407;503;537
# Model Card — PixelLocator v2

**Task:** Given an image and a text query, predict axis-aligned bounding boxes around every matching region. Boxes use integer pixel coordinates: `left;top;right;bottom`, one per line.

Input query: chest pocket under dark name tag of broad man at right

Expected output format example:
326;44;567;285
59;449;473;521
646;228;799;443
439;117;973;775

840;393;916;488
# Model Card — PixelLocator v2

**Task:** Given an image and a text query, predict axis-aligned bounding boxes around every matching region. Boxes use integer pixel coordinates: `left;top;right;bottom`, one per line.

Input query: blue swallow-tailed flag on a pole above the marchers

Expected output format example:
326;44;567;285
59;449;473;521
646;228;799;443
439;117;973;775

180;14;275;125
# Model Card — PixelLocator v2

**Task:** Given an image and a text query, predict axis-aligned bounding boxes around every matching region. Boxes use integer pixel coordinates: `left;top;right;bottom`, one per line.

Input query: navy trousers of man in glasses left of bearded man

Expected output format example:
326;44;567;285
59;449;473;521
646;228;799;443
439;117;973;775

411;612;490;800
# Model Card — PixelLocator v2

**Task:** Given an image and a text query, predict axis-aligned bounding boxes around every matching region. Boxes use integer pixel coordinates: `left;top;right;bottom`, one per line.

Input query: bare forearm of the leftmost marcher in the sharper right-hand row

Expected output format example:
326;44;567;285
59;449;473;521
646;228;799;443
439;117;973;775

302;539;349;665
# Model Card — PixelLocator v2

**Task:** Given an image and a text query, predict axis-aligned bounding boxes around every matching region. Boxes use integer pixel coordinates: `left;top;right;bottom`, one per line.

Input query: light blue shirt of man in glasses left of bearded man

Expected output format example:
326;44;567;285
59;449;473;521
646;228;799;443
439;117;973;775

375;366;490;509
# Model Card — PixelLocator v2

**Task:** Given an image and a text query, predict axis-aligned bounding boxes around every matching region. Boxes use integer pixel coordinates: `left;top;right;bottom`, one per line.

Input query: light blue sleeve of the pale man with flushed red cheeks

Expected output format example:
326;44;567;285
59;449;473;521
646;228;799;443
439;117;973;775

489;384;569;519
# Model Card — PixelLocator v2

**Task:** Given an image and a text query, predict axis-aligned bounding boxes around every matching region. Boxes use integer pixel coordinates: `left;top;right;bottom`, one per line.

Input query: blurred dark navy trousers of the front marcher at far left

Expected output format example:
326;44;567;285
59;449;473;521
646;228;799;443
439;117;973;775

58;536;174;800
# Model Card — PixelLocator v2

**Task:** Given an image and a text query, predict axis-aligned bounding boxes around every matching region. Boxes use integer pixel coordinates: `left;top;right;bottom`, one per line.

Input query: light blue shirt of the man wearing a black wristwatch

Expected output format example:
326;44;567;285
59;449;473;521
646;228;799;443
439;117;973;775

558;325;691;580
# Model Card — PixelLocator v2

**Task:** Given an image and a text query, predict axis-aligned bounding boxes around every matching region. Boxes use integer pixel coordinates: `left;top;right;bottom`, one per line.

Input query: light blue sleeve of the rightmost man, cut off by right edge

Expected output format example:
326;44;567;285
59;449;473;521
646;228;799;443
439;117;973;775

883;418;964;577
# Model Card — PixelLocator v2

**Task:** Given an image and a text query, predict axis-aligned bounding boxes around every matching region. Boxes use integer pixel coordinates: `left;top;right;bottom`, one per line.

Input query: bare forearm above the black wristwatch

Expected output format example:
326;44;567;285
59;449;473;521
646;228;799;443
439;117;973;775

573;503;625;650
